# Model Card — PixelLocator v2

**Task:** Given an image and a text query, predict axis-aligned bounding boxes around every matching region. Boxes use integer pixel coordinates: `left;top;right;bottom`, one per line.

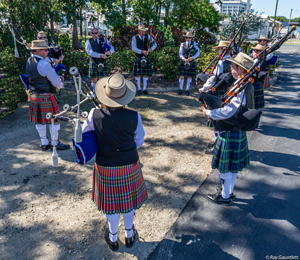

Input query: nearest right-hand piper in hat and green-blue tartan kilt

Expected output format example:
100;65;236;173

203;52;254;205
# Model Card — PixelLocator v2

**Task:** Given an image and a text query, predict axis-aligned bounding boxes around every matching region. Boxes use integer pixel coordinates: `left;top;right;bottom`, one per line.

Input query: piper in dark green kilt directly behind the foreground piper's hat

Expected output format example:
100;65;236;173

85;27;114;92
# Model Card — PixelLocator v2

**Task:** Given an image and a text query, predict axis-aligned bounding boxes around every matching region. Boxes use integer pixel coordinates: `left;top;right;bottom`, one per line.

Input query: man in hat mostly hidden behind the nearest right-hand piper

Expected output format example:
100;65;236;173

199;41;231;154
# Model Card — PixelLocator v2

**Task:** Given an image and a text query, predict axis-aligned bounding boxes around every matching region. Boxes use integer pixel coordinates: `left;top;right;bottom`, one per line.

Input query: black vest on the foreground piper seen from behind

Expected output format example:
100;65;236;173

94;108;139;167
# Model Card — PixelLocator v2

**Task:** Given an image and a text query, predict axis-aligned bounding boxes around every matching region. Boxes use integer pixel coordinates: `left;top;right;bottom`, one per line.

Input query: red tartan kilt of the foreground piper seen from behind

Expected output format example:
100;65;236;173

92;161;148;215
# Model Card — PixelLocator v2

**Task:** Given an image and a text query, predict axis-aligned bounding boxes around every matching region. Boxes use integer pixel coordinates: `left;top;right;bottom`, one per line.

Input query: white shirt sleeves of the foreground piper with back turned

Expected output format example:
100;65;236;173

82;108;145;149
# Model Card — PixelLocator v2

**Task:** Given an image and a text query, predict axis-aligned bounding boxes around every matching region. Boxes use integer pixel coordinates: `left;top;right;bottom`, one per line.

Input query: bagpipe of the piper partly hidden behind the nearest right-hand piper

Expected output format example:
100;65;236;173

196;22;245;87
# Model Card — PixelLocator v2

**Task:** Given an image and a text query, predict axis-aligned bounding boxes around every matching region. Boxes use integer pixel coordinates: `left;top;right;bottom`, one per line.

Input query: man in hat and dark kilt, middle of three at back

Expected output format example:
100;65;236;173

131;25;157;95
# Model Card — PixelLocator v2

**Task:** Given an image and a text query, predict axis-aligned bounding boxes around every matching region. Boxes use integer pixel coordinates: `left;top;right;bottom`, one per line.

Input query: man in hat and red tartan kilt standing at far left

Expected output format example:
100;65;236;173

26;40;70;151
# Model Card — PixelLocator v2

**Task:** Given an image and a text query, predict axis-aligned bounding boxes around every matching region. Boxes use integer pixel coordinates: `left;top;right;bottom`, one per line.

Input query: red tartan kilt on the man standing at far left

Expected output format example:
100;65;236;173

29;93;59;125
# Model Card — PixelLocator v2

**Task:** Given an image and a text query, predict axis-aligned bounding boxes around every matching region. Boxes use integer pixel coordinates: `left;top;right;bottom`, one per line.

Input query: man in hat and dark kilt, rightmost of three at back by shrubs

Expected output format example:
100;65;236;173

178;32;200;96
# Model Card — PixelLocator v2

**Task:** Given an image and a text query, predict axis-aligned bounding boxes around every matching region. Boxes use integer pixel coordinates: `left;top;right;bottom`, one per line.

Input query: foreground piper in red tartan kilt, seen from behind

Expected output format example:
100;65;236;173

83;73;148;250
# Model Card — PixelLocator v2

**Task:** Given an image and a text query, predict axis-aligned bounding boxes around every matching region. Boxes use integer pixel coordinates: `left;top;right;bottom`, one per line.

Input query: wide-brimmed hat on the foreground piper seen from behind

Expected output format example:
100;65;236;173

96;73;136;107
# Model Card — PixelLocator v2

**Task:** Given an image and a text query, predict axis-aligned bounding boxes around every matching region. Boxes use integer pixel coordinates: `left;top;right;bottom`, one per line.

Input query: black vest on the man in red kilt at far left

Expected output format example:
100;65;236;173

26;56;56;94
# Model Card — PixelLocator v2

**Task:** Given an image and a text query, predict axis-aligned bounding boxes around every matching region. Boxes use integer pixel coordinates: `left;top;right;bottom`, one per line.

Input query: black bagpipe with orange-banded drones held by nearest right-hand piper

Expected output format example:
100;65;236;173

199;26;296;131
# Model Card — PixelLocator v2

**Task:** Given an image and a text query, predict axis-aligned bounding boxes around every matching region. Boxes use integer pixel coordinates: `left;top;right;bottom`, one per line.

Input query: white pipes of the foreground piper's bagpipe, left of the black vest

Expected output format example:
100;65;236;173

46;67;101;166
